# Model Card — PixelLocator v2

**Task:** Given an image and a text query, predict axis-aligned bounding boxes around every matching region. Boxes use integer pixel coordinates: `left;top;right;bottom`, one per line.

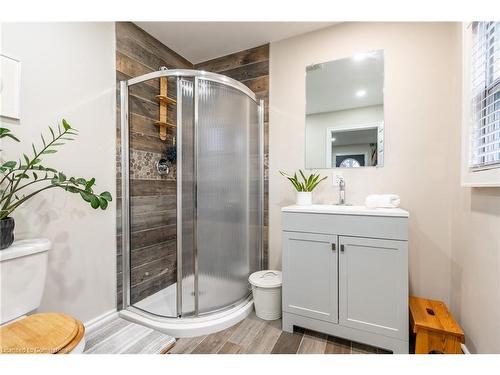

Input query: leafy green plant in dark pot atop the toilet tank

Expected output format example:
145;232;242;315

0;119;112;250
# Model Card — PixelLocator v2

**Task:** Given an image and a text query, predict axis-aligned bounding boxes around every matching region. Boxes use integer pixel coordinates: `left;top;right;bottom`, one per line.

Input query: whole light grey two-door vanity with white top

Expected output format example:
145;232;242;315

282;205;408;353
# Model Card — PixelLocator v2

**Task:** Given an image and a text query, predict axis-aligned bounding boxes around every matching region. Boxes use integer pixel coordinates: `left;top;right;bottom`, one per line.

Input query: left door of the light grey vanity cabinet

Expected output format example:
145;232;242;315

283;231;338;323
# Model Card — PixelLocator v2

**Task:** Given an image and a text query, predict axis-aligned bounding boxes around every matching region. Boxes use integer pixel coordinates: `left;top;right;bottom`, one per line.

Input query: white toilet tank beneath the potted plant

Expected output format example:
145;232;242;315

0;239;51;324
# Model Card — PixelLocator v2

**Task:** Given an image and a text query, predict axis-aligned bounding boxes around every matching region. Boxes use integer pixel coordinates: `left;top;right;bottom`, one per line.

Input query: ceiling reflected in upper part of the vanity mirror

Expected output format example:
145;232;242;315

306;51;384;114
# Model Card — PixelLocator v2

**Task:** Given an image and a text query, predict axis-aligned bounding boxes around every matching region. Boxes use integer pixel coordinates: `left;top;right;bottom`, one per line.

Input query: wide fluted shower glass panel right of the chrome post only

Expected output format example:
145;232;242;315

195;78;260;314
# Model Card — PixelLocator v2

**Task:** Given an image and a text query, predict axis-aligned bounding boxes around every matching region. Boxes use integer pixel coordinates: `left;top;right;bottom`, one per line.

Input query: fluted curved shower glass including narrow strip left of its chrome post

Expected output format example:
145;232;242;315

177;78;262;316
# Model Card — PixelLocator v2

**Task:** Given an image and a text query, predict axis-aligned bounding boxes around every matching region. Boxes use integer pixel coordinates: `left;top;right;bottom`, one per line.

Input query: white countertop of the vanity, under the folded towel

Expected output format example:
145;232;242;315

281;204;410;217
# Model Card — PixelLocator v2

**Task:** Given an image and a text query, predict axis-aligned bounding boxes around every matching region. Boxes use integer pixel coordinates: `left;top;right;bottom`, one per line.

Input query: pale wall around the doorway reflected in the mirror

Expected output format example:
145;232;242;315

305;105;384;168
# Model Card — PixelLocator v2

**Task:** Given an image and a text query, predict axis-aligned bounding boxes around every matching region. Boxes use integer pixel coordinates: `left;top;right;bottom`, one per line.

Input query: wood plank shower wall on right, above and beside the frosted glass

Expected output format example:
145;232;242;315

194;44;269;268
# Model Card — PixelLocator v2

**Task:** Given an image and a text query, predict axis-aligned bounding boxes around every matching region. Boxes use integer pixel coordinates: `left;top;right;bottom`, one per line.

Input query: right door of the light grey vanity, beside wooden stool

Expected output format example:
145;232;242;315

339;237;408;339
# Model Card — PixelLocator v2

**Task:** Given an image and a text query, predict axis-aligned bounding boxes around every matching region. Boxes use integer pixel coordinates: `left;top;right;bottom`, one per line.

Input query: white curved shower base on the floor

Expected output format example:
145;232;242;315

120;274;253;338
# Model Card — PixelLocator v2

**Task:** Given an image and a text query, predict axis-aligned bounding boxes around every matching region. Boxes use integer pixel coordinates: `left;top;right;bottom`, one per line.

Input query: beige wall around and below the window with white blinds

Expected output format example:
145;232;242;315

450;25;500;353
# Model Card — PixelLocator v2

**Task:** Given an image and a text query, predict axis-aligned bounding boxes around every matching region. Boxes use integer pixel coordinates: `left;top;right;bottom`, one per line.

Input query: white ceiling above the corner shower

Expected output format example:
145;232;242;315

135;22;337;64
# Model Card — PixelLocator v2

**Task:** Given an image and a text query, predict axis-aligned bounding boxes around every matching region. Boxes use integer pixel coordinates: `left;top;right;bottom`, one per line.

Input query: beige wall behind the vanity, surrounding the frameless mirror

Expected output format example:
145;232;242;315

269;23;460;312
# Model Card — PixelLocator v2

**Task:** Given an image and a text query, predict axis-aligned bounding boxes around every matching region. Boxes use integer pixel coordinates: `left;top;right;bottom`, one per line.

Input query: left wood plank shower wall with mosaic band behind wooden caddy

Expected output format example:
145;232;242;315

116;22;193;309
